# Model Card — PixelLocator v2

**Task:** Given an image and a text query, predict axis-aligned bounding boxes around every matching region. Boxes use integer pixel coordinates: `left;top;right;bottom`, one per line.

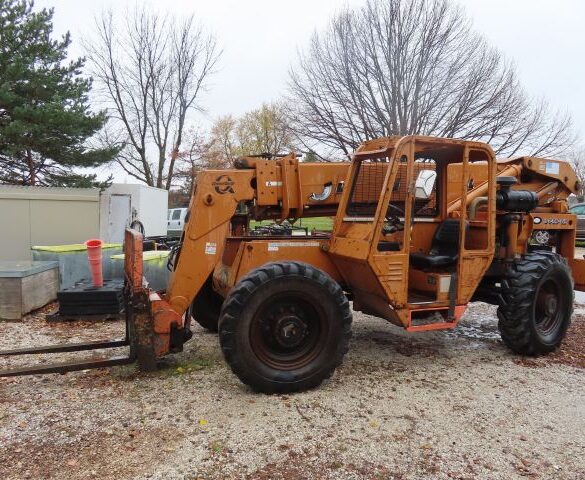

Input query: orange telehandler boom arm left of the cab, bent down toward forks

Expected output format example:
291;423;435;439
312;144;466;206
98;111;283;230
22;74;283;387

166;154;348;314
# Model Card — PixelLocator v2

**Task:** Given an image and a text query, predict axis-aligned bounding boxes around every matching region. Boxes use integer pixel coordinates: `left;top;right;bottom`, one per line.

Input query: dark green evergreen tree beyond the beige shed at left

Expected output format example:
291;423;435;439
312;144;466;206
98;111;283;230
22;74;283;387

0;0;118;186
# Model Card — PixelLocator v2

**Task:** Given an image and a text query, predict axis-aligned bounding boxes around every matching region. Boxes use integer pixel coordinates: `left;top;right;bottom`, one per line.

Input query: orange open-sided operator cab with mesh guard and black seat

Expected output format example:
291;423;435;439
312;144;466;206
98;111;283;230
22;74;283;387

330;136;495;327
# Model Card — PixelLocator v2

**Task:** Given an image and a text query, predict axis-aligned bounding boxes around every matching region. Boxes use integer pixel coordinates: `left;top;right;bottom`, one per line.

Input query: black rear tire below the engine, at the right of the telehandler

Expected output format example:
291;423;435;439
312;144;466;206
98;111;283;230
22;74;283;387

498;251;574;356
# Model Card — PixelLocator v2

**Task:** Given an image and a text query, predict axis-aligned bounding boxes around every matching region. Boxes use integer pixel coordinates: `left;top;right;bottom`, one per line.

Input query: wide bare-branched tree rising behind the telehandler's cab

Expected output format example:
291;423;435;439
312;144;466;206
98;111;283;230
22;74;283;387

290;0;573;156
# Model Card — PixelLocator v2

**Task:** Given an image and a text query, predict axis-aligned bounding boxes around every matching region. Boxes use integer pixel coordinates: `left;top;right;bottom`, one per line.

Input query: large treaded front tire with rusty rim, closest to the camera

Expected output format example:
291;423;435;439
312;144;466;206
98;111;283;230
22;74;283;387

219;262;352;393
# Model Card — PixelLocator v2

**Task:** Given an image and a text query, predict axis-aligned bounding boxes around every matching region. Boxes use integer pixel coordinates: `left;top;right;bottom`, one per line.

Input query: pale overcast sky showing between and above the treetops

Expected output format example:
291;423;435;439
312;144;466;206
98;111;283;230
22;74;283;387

35;0;585;182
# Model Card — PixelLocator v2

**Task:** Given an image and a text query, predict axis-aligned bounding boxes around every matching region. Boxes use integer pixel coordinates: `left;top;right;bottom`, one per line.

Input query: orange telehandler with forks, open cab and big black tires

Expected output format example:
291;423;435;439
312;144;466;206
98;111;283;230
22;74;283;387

3;136;585;392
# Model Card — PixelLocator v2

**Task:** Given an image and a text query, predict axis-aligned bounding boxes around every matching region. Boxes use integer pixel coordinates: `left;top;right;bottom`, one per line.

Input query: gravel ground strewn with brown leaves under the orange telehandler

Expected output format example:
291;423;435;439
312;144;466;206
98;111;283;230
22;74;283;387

0;303;585;480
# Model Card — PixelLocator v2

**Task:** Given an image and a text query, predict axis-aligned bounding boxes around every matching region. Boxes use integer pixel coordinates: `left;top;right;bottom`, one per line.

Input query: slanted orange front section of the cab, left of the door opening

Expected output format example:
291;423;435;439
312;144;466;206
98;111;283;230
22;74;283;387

329;137;412;324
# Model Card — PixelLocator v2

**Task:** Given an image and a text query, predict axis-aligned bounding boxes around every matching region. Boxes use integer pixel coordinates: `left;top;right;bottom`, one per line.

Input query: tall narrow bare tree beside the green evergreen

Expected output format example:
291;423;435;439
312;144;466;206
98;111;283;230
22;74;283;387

85;8;221;189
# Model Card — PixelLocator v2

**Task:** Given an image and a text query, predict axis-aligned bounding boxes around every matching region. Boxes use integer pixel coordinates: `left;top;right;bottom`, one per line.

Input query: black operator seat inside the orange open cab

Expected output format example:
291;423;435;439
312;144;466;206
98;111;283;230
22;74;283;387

410;218;469;270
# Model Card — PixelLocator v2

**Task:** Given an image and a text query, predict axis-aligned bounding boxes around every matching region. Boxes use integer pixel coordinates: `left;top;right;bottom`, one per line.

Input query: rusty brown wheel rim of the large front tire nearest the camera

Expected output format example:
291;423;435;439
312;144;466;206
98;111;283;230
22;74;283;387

250;293;327;370
